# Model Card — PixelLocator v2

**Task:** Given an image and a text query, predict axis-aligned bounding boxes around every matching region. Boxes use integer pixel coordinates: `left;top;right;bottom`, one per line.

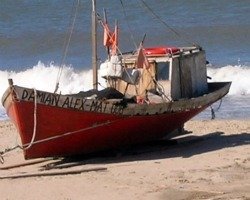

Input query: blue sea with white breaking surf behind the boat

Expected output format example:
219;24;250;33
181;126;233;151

0;0;250;119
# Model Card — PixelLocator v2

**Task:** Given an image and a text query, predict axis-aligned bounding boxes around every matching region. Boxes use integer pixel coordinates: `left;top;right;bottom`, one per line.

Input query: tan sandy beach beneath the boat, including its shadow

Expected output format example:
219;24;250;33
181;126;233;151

0;120;250;200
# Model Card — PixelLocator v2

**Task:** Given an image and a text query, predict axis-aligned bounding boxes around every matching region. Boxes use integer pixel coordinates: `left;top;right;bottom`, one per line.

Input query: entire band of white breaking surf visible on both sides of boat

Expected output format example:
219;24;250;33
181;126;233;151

0;61;250;96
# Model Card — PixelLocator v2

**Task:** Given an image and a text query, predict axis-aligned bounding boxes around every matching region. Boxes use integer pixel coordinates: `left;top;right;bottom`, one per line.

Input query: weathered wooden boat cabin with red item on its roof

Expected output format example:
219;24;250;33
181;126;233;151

100;47;208;102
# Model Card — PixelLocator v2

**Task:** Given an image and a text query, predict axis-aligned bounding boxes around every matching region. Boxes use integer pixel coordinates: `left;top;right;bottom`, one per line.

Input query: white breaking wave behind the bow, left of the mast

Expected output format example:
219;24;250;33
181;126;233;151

0;61;106;96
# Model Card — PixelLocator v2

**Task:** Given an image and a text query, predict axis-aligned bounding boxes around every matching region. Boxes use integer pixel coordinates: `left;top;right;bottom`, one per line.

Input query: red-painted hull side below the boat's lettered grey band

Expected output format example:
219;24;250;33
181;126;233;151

4;82;229;159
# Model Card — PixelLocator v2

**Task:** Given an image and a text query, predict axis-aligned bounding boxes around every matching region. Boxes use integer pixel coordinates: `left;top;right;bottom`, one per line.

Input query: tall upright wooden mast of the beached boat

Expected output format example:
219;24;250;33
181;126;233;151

92;0;98;90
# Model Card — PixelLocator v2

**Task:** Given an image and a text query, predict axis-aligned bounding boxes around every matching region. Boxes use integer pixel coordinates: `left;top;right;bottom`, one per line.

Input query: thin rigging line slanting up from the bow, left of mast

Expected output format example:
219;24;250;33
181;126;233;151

54;0;80;93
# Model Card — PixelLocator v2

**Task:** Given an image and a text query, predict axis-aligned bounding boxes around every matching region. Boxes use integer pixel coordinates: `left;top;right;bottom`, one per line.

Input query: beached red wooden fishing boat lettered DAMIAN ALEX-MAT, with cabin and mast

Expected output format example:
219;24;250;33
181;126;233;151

2;0;231;159
